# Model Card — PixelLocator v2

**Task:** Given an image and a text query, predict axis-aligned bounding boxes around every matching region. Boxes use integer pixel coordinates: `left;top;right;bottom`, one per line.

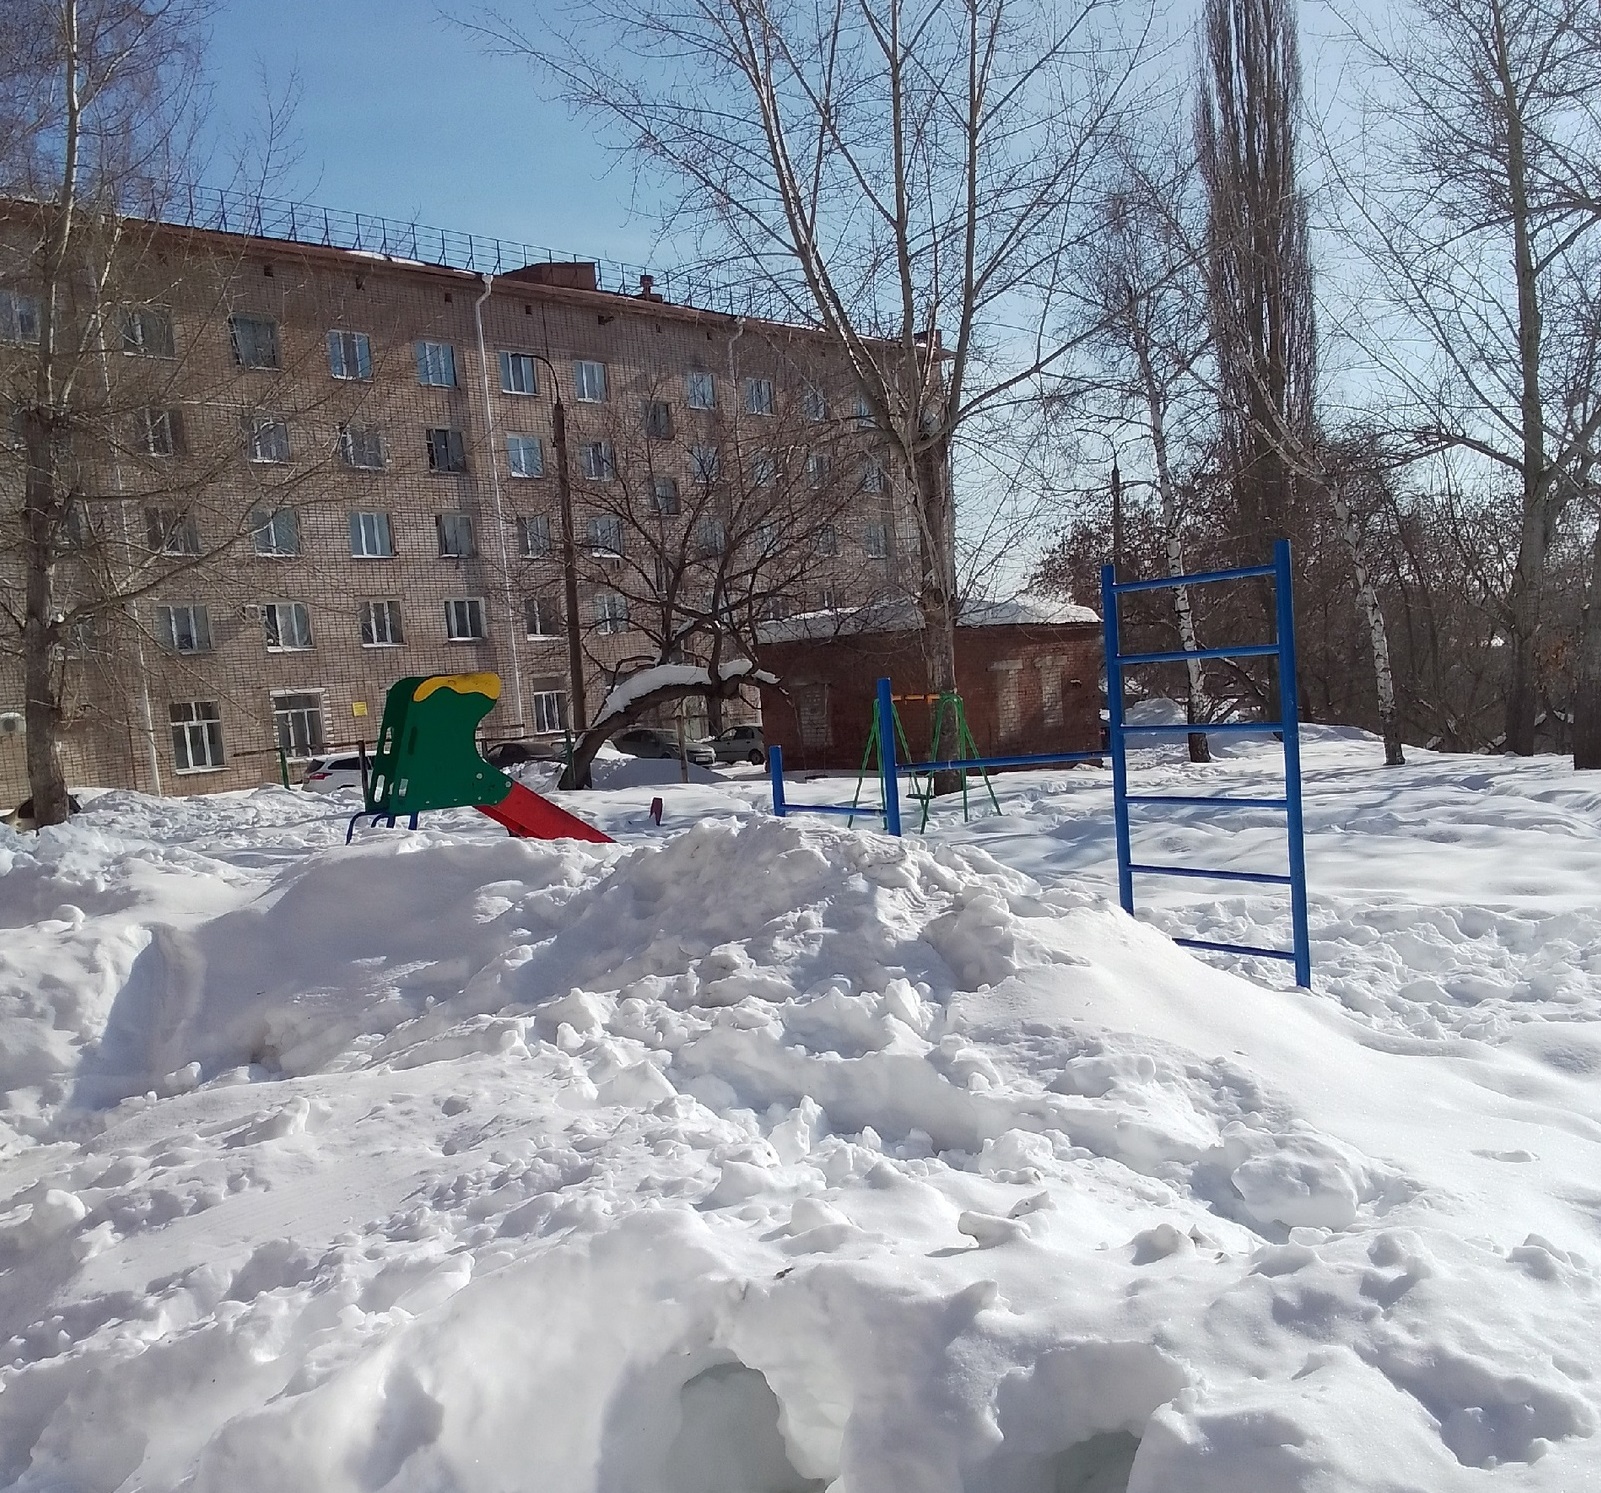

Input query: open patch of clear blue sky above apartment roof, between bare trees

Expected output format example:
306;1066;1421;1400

201;0;664;266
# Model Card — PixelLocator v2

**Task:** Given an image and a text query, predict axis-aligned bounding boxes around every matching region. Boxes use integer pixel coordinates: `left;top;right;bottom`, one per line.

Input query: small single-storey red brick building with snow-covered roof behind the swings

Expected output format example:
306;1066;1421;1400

762;597;1103;770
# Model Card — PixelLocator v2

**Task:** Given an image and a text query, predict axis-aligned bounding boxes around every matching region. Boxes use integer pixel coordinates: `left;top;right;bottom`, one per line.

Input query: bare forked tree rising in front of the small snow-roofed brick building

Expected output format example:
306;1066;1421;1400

479;0;1143;742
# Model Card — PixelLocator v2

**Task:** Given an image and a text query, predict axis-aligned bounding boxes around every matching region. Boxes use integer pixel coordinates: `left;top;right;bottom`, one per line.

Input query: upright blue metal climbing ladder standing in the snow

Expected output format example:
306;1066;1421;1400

1101;539;1311;989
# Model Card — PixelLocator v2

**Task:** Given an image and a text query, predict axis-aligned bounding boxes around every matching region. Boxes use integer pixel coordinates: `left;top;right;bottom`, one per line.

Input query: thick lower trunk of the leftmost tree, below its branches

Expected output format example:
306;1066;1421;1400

22;410;69;827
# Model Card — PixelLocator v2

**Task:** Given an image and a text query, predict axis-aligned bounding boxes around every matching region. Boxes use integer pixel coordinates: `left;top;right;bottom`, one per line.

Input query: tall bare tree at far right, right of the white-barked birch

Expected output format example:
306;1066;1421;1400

1346;0;1601;754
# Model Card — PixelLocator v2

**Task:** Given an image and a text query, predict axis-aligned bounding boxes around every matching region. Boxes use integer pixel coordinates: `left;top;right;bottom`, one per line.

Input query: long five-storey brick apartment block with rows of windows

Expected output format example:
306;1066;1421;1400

0;204;917;803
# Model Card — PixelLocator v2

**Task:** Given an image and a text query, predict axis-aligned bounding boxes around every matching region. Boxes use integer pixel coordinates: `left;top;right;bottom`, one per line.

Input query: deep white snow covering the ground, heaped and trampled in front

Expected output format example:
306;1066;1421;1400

0;733;1601;1493
